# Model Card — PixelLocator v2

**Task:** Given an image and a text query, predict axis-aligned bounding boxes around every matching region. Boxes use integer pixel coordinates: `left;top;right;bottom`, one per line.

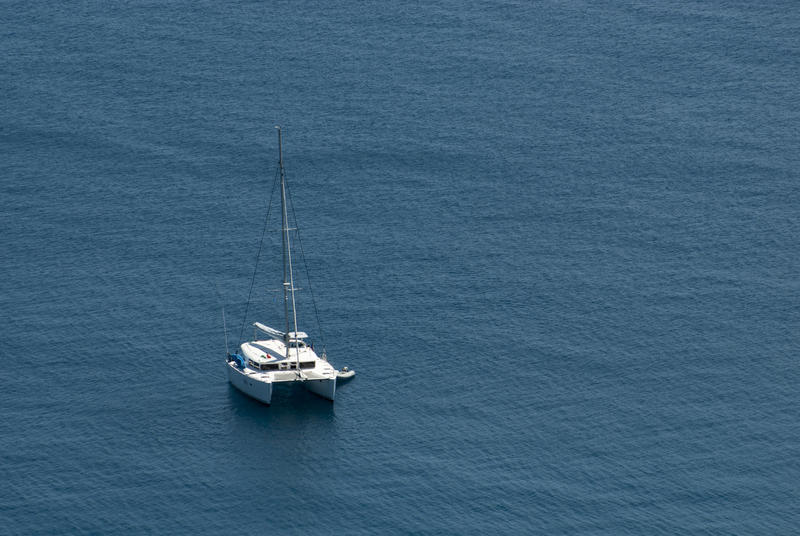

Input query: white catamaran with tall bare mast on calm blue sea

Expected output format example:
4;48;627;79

223;127;353;404
